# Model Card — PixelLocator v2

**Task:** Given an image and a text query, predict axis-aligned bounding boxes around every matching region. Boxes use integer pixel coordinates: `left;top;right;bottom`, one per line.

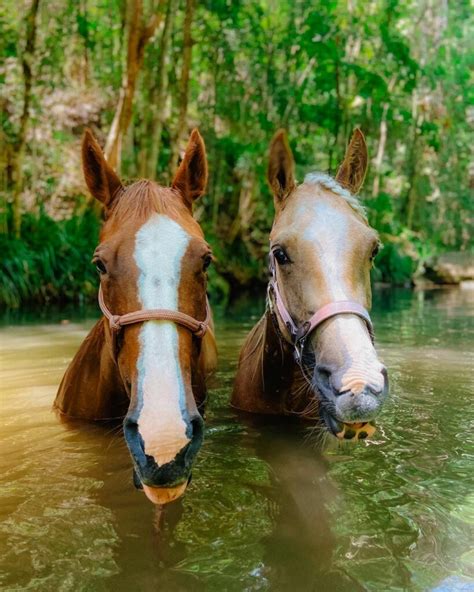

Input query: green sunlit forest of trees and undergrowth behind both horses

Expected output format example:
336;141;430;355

0;0;474;306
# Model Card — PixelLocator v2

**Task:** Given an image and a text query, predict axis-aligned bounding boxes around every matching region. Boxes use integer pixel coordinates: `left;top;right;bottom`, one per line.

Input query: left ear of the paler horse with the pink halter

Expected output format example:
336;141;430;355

267;130;296;205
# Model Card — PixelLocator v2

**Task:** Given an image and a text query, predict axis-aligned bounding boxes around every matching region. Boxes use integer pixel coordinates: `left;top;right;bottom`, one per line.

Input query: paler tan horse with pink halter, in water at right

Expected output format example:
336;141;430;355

232;130;388;440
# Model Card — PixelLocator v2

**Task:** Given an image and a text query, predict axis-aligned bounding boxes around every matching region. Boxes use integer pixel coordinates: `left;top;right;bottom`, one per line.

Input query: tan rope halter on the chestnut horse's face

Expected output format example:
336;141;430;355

98;286;211;361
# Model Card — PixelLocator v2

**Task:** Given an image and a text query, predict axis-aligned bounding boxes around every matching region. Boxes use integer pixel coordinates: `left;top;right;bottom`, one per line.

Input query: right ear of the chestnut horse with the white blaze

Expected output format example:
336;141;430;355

171;129;207;210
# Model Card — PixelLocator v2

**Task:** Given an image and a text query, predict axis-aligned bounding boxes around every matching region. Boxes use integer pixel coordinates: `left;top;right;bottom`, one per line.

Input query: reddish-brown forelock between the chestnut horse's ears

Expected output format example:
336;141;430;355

109;179;187;223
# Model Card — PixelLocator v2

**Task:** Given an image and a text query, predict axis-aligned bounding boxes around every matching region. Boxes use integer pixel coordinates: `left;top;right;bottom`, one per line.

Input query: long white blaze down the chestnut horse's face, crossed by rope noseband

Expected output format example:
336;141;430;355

134;214;191;466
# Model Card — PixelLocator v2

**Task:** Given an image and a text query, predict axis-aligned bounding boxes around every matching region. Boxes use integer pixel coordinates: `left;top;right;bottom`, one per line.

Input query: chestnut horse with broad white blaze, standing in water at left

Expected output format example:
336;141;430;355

54;130;216;504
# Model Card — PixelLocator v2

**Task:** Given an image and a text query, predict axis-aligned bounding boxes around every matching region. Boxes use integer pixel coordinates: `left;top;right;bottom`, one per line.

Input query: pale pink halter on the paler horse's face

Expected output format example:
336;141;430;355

268;251;374;368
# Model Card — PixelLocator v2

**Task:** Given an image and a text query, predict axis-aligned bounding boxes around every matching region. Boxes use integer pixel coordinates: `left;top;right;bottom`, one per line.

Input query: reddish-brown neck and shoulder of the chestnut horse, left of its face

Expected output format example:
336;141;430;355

53;319;129;420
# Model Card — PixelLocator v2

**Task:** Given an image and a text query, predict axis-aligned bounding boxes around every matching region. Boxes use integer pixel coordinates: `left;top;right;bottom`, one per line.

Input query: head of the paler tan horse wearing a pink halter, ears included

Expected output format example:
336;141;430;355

268;130;388;439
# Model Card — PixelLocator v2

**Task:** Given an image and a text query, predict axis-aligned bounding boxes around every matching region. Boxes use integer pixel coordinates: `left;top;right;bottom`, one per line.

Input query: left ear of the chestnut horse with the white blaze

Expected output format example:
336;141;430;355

82;129;122;208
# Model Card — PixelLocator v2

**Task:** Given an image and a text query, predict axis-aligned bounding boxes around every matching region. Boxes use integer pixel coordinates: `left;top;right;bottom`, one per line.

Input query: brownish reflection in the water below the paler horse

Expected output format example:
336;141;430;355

237;418;364;592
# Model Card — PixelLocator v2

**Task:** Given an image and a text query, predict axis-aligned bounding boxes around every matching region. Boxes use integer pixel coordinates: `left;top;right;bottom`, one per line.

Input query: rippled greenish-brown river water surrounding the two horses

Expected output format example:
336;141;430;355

0;289;474;592
